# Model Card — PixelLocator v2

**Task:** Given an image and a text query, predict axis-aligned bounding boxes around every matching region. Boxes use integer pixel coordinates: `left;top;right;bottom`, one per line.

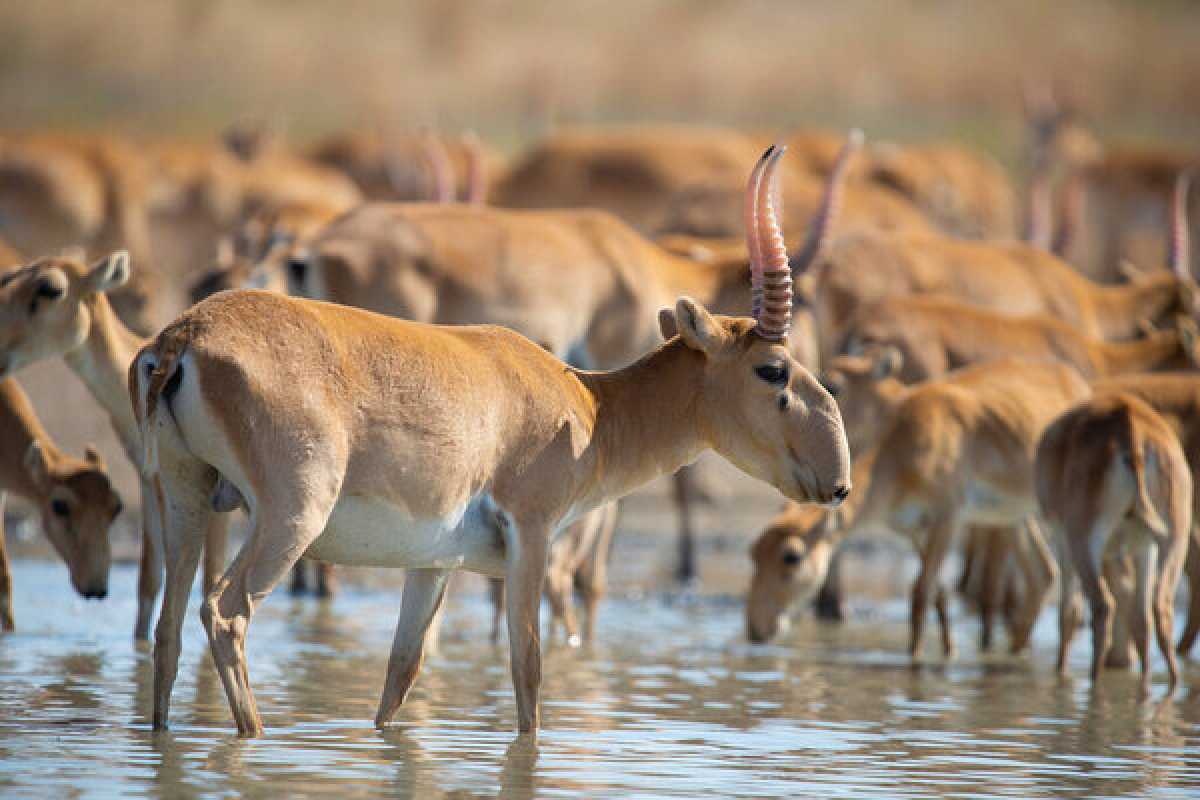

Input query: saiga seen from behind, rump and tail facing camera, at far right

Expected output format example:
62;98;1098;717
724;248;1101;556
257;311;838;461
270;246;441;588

1036;392;1192;696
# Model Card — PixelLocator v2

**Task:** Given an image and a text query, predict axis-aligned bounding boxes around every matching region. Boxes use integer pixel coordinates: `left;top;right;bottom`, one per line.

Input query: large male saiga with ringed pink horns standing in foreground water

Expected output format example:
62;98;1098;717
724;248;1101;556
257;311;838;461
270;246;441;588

130;145;850;735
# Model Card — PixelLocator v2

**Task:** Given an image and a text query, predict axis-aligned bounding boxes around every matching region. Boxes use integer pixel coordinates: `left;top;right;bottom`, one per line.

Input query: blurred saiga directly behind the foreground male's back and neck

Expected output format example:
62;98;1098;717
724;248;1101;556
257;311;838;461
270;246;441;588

289;134;862;579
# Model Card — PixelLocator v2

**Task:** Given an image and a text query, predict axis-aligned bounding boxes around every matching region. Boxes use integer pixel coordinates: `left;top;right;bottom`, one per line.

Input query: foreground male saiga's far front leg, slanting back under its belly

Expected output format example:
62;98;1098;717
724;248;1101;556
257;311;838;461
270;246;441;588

376;570;450;728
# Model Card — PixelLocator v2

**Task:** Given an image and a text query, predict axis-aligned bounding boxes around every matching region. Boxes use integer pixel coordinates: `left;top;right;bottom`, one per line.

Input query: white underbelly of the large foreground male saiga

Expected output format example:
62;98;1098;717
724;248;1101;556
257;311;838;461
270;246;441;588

305;495;505;576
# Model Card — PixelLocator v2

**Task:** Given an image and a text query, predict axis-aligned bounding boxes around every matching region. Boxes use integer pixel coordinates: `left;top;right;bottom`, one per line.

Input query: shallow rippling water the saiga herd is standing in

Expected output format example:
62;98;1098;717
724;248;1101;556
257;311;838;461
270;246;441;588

0;549;1200;798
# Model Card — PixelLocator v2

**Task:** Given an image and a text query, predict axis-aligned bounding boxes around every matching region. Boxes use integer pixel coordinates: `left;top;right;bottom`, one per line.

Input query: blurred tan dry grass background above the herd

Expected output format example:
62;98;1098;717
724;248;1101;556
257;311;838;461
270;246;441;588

0;0;1200;156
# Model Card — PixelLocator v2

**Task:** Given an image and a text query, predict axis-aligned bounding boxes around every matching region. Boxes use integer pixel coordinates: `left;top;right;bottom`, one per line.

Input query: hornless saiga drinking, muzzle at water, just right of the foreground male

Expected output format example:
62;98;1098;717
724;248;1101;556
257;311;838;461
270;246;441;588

746;356;1091;656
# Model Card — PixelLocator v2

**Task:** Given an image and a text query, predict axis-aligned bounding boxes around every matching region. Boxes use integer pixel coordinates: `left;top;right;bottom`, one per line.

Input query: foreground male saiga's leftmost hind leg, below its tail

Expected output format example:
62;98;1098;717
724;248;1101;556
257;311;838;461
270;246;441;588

154;474;216;730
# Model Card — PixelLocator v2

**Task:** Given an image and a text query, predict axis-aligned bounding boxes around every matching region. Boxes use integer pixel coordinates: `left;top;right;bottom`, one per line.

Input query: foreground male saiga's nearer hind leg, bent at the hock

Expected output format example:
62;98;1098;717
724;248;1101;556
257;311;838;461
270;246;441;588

200;470;344;736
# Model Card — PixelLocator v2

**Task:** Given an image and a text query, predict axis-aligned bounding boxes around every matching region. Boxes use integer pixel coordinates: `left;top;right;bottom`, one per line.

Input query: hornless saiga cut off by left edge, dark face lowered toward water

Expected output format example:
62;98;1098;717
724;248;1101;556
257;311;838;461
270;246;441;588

0;378;121;631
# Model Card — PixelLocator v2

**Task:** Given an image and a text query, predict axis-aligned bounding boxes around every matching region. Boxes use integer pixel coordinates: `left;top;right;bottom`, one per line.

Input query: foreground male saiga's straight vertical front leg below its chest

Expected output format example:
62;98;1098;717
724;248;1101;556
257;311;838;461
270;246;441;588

499;511;550;733
